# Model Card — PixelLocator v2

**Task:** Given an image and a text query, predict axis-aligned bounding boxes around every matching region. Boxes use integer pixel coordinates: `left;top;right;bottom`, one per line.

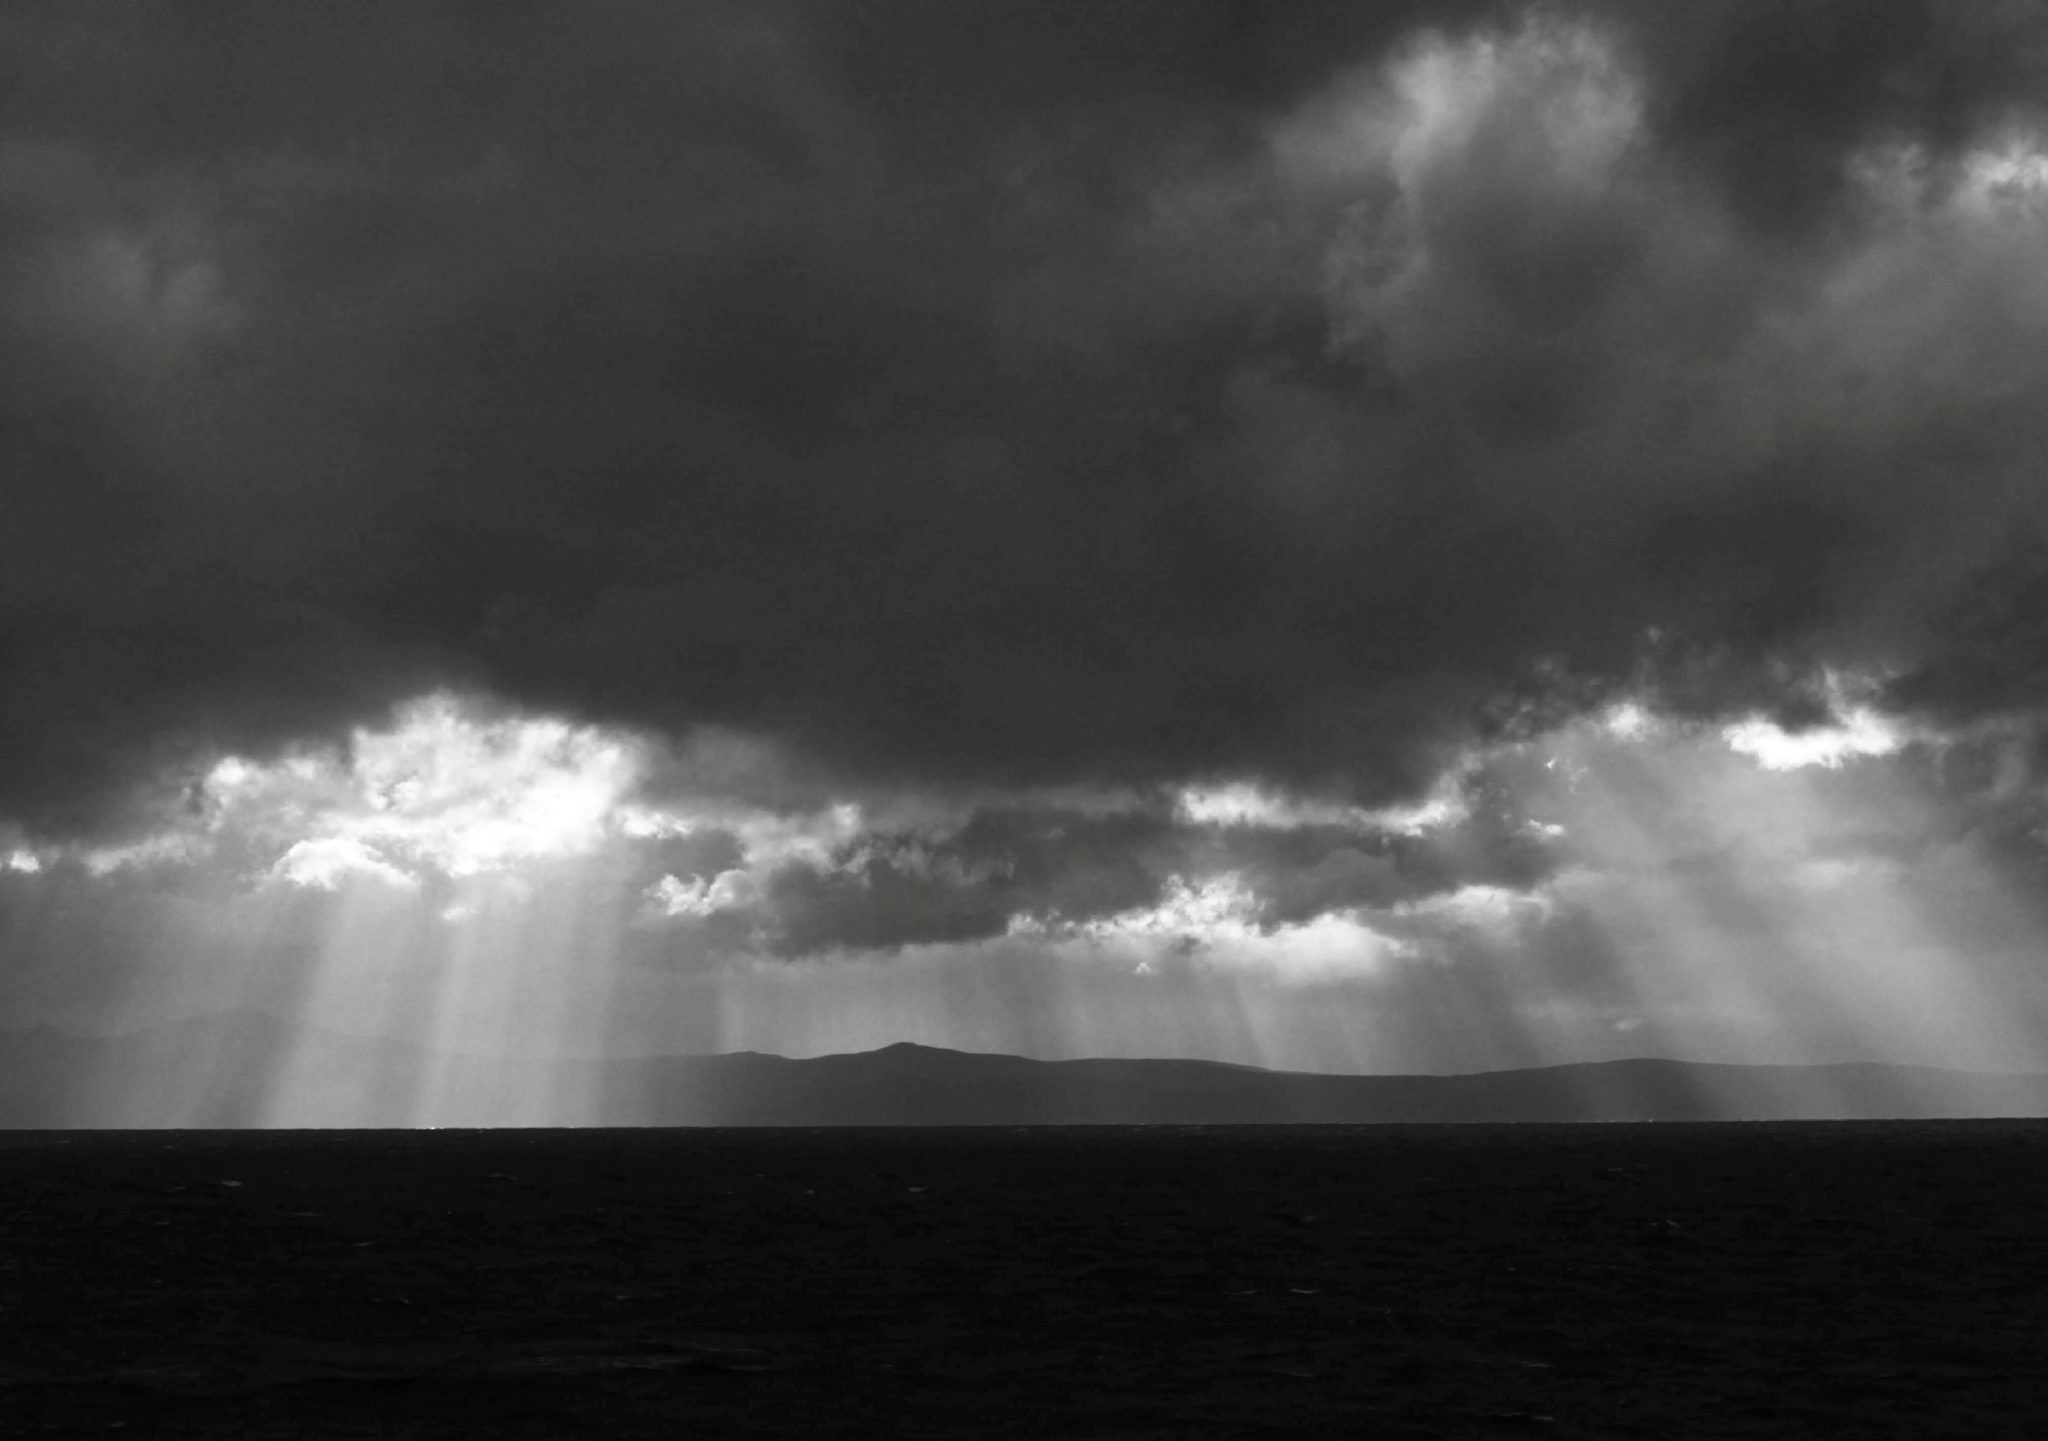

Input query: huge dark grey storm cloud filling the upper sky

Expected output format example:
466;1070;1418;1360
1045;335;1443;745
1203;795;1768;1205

0;2;2048;843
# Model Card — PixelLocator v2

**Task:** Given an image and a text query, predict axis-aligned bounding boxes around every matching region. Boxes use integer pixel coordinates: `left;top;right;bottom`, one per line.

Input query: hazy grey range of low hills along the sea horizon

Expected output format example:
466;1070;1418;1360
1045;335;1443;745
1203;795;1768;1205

0;1013;2048;1128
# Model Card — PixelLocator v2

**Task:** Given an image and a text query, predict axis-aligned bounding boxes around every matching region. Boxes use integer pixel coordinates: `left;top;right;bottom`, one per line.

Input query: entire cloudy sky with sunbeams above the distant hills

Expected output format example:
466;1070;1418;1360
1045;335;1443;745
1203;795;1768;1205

0;0;2048;1097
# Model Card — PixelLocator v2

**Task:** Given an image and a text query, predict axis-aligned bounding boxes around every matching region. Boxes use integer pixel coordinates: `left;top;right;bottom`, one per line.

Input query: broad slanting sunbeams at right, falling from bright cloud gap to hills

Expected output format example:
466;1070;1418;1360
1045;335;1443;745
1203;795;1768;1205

1524;708;2044;1068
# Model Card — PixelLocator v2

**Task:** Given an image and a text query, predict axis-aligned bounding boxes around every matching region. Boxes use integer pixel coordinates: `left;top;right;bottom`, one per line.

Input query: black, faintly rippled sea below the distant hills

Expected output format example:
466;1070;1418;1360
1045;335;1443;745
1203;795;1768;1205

12;1122;2048;1437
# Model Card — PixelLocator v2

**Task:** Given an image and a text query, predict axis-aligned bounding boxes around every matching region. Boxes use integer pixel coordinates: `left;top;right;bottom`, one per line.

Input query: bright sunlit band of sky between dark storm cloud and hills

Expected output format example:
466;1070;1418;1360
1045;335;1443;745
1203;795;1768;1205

0;700;2048;1080
